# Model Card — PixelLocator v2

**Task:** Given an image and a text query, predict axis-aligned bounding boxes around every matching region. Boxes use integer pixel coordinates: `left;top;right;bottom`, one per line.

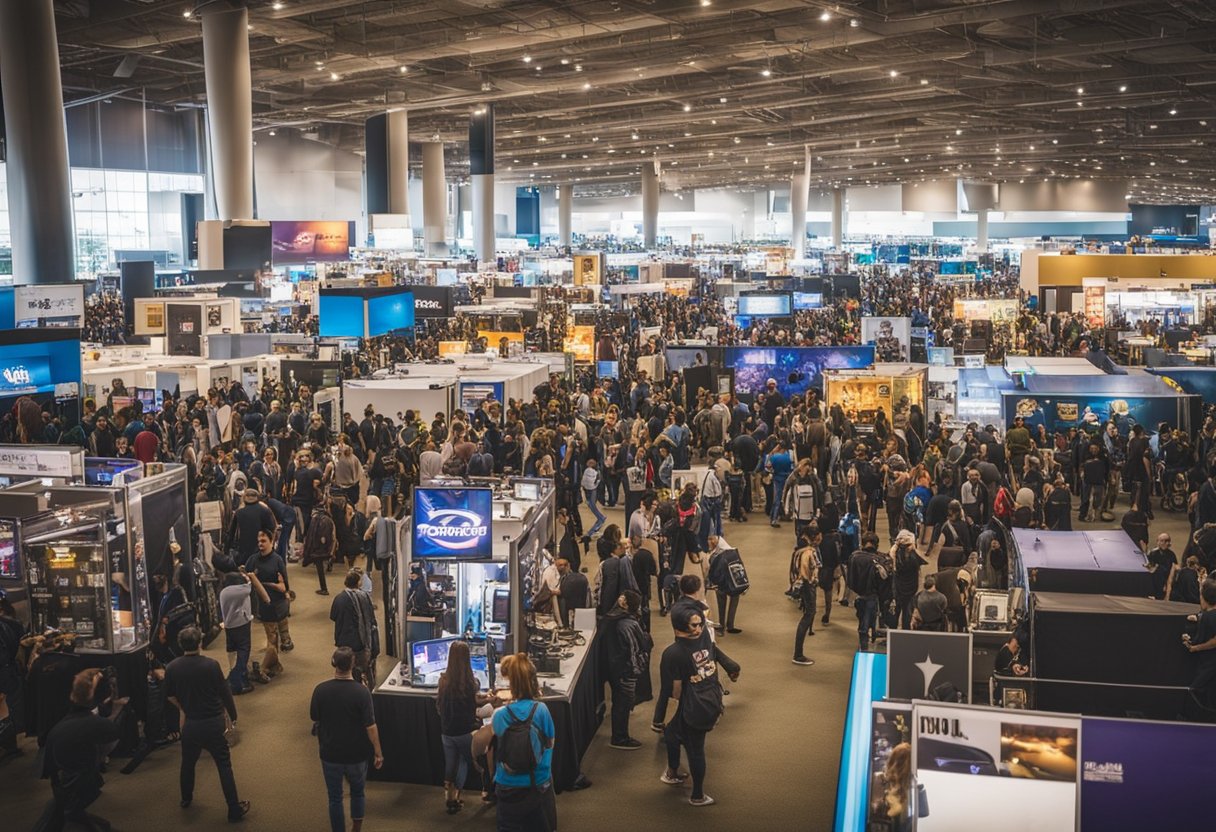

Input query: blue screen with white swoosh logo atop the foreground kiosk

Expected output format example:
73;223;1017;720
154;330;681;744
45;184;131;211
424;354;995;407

413;488;494;561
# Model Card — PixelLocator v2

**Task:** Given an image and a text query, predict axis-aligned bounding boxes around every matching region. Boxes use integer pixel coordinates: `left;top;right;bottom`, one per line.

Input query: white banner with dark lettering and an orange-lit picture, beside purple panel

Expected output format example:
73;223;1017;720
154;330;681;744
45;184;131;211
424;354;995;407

913;703;1079;832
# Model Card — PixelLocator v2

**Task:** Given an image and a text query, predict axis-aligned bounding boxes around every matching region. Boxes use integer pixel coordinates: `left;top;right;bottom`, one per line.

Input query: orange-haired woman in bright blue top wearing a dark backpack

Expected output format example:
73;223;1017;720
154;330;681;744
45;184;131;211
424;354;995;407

491;653;557;832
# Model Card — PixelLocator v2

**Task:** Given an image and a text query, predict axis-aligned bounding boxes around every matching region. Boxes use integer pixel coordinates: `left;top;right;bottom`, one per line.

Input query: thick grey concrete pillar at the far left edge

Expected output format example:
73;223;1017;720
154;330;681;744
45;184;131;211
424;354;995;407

0;0;75;285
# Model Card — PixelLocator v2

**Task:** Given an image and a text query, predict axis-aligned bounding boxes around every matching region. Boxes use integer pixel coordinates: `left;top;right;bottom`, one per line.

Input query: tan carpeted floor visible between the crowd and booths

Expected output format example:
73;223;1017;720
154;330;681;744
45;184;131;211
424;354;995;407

0;493;1186;832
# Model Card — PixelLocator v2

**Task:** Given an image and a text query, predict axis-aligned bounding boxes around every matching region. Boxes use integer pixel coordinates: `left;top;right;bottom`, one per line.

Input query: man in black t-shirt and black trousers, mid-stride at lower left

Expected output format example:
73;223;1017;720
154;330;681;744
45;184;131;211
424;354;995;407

164;626;249;822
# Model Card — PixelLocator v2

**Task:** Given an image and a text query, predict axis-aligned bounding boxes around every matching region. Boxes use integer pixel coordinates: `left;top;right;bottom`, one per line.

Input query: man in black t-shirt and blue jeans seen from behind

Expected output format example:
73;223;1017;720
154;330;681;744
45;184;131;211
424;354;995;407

309;647;384;832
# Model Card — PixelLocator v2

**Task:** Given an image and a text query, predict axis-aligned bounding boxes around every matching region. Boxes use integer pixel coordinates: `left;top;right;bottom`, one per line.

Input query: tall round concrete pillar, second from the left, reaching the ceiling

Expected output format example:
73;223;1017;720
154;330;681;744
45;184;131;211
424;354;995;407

202;4;253;220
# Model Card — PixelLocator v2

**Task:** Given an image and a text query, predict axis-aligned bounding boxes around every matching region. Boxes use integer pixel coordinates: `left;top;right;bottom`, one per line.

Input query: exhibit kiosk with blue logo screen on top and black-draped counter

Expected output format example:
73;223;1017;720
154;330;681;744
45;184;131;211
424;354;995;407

368;478;603;791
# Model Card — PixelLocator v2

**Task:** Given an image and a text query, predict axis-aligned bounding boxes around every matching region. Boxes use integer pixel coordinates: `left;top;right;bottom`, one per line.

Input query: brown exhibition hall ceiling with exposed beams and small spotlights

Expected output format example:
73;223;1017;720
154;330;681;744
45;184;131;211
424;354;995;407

55;0;1216;203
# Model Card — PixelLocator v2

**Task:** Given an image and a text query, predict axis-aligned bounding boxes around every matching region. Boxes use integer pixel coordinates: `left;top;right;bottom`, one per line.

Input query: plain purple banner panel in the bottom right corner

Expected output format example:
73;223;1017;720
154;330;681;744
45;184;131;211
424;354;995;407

1081;716;1216;832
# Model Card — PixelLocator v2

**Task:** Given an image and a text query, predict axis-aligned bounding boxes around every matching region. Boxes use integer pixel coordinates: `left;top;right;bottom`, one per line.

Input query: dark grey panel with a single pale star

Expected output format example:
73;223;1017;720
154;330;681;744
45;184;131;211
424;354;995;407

886;630;972;702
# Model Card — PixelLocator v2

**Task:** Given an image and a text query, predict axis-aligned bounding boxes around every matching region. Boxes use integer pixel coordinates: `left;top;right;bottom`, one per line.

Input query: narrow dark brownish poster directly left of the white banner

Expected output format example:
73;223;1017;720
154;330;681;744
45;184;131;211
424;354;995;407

866;702;914;832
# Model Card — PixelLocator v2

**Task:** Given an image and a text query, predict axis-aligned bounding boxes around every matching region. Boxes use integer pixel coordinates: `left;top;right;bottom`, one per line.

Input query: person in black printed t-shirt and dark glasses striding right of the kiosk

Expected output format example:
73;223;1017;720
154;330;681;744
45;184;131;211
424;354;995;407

659;609;739;806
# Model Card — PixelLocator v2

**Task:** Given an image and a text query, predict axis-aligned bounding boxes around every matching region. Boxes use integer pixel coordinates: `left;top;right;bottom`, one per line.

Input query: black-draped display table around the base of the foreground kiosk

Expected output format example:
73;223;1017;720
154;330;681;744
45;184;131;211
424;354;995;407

367;609;604;792
